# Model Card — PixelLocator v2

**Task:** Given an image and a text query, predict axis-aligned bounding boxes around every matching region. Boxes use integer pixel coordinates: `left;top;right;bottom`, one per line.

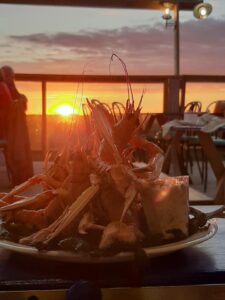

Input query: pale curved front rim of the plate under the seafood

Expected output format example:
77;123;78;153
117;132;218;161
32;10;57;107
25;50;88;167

0;219;218;263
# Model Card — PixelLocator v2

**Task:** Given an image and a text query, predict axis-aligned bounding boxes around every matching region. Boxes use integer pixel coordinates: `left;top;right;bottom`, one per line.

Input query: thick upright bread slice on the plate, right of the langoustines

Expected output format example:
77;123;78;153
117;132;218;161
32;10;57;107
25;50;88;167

141;176;189;243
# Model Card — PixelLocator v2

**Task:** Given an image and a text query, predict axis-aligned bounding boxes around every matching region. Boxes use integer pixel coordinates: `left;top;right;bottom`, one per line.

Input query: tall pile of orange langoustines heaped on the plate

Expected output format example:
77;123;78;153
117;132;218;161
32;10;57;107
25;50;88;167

0;55;167;253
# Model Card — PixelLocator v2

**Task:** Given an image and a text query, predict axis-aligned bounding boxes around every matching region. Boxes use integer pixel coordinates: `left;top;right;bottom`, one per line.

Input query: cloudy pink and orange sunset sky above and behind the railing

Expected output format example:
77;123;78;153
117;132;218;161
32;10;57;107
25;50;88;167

0;0;225;113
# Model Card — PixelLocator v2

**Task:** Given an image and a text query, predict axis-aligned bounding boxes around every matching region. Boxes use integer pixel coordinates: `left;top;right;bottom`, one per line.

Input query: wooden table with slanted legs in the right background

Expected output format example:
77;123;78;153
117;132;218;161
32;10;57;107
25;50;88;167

163;124;225;204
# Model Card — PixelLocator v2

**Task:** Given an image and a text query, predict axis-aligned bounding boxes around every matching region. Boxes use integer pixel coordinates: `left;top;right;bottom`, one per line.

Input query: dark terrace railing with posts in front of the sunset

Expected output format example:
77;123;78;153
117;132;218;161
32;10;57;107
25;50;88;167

13;74;225;158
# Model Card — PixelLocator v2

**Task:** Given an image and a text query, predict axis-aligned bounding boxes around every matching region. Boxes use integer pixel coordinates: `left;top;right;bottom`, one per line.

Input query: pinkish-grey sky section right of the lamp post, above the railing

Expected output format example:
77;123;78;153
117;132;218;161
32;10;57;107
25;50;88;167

180;0;225;75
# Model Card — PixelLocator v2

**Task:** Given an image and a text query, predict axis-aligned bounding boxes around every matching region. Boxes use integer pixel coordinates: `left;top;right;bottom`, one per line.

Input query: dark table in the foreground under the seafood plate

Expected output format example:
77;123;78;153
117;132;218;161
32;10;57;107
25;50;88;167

0;206;225;300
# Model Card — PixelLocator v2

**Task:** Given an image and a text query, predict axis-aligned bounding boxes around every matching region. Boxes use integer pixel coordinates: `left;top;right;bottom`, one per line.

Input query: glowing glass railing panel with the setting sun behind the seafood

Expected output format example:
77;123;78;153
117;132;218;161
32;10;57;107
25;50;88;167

46;83;163;150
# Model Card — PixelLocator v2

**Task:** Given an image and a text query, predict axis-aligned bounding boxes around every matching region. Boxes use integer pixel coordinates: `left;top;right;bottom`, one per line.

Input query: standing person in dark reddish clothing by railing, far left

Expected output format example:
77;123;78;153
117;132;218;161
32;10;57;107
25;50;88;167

0;66;33;186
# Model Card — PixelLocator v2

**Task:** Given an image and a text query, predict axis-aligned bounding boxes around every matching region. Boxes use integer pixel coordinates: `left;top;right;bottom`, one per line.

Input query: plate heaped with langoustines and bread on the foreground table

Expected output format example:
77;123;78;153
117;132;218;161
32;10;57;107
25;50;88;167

0;56;220;262
